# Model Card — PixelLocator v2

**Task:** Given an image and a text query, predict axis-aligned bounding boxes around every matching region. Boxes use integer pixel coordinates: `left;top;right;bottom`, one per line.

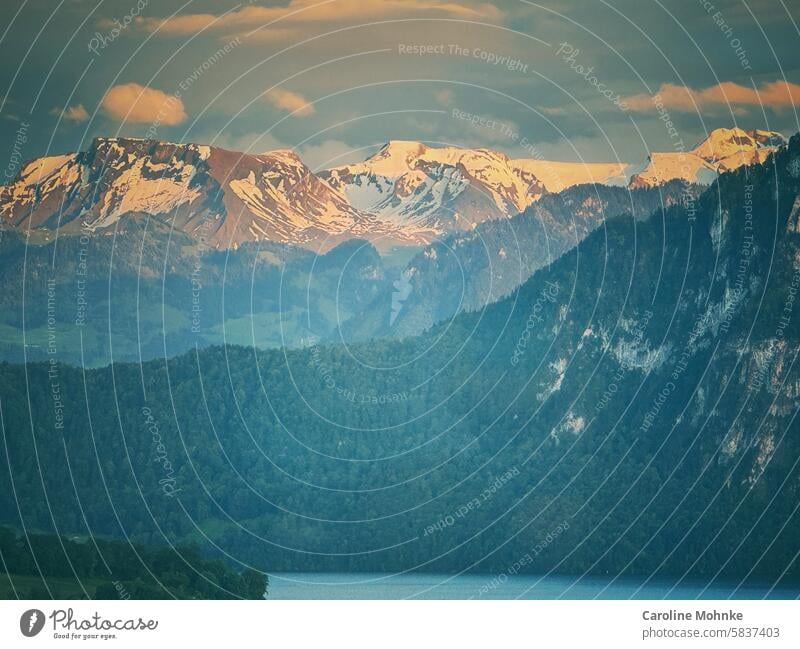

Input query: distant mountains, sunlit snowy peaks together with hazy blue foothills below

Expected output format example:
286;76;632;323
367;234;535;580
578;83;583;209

0;129;780;366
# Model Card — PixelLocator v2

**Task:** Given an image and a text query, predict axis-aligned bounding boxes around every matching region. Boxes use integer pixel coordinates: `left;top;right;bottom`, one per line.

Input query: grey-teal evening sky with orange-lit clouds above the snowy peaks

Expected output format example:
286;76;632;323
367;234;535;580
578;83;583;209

0;0;800;172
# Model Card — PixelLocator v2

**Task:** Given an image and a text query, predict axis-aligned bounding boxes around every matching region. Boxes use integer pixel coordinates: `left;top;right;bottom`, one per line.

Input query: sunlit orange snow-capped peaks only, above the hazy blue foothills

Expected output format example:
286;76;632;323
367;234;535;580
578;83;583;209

0;128;785;251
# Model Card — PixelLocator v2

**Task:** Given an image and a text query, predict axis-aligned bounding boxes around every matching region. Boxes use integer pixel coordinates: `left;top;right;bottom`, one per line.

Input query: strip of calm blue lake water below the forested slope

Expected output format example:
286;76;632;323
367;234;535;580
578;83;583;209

268;573;800;599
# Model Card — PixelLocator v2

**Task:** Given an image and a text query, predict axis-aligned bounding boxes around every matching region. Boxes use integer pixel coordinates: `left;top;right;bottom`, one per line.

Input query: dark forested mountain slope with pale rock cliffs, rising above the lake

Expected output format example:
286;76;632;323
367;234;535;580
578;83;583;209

0;136;800;592
